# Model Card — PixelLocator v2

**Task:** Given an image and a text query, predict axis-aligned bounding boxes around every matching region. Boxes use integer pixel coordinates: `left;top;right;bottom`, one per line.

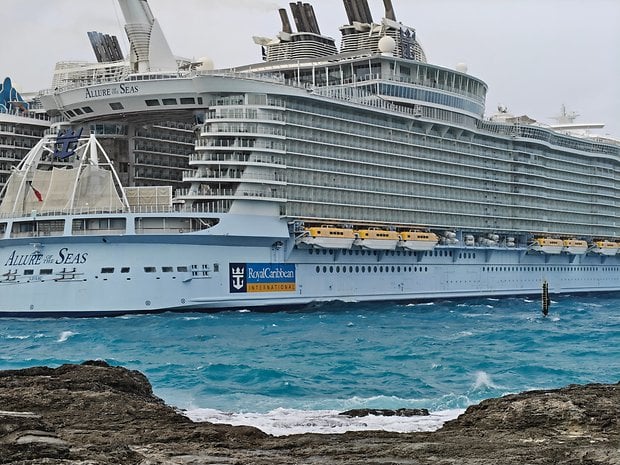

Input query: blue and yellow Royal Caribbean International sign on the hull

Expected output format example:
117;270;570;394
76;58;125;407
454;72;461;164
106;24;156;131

228;263;296;294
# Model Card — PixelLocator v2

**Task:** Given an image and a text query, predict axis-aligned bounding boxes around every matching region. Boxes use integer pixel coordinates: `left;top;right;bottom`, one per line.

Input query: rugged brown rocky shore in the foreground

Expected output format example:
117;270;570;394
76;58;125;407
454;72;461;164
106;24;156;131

0;362;620;465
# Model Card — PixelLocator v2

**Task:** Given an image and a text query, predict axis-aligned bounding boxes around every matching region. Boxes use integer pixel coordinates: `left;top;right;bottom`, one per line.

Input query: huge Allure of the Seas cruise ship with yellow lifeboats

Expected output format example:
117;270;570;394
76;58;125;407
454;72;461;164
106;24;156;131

0;0;620;316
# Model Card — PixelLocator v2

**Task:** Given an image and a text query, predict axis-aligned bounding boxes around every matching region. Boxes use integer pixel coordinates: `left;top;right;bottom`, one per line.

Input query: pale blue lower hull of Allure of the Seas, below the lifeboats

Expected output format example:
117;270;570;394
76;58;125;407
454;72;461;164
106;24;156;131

0;215;620;316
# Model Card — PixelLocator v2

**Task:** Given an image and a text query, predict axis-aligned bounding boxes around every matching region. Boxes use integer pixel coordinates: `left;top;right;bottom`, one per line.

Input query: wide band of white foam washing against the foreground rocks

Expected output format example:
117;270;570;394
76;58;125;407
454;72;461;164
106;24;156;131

185;408;463;436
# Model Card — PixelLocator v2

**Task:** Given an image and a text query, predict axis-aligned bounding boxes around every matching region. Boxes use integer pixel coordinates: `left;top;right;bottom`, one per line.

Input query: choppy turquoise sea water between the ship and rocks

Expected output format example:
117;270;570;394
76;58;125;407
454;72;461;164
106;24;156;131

0;294;620;435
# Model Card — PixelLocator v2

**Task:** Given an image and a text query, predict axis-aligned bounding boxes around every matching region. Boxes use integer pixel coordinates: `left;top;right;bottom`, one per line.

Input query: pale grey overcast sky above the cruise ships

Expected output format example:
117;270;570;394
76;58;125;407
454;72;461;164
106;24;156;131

0;0;620;137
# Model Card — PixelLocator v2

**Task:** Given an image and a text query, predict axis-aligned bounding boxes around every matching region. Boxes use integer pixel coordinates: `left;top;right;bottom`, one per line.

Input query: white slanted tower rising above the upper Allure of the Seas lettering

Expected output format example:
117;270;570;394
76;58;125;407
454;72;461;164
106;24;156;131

118;0;178;73
